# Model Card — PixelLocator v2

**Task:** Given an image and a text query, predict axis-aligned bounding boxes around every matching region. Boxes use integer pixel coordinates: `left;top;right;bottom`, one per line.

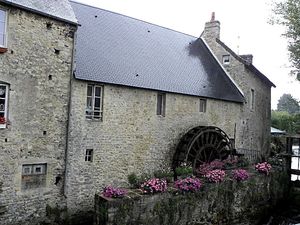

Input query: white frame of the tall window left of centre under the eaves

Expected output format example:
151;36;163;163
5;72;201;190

85;84;103;121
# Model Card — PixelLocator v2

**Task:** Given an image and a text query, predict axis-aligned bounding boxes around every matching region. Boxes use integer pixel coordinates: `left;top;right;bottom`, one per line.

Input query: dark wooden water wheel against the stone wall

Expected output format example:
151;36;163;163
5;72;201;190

173;126;233;170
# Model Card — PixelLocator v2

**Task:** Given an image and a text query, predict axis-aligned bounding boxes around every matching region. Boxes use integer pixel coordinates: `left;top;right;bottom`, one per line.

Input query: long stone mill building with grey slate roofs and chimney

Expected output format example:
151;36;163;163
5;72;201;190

0;0;274;225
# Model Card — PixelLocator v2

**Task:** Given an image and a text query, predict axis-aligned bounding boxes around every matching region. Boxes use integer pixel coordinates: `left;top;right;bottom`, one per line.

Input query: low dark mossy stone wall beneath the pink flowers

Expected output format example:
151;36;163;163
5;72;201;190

94;172;289;225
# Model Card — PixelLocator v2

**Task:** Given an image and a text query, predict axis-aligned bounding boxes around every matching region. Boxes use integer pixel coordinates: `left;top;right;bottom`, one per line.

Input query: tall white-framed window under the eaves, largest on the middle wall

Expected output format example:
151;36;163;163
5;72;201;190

86;84;103;120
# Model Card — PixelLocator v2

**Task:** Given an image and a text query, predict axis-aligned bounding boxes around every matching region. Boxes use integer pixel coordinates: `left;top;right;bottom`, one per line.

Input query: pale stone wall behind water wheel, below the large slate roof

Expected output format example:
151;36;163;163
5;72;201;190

66;80;243;216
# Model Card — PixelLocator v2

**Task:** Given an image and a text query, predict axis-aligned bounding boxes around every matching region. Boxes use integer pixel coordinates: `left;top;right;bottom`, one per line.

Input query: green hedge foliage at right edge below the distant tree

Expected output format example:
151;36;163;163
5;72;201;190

271;110;300;134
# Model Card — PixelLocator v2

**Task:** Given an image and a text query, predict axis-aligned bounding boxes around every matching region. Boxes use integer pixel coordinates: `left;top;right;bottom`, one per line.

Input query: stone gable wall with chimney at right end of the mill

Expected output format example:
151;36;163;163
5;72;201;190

202;21;271;156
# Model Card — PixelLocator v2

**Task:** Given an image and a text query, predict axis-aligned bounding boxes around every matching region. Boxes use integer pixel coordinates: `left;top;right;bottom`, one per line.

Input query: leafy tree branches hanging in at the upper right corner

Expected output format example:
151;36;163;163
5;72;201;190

272;0;300;81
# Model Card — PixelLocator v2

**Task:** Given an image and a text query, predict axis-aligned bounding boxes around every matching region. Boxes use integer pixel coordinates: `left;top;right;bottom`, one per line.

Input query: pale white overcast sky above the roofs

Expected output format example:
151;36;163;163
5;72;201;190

76;0;300;109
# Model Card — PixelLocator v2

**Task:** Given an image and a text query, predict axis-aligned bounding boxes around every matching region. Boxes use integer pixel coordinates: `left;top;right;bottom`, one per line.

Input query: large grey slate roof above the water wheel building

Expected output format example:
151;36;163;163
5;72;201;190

71;2;244;102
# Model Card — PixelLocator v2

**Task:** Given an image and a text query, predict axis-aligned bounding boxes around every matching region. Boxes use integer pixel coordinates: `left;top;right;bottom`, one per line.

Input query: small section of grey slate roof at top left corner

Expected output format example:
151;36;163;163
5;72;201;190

0;0;77;24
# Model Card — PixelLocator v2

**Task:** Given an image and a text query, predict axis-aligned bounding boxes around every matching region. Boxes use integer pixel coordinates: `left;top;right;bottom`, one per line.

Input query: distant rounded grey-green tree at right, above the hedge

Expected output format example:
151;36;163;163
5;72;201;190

277;94;300;114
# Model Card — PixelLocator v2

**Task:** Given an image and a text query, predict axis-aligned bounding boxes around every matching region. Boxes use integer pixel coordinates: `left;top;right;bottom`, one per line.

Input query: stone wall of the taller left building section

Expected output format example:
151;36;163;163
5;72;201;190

0;3;75;225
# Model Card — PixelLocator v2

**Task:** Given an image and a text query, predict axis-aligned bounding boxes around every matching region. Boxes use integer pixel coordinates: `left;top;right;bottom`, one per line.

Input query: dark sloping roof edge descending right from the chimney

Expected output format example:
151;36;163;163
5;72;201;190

216;38;276;87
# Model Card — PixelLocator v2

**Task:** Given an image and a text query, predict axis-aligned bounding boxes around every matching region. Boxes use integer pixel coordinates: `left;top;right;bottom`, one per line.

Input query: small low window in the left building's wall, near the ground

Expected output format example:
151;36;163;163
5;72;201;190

21;163;47;190
